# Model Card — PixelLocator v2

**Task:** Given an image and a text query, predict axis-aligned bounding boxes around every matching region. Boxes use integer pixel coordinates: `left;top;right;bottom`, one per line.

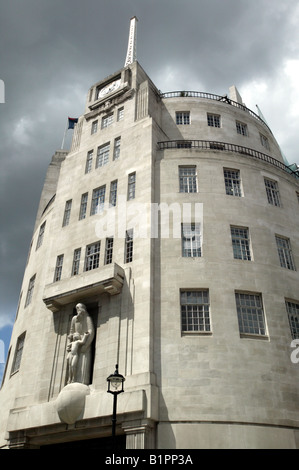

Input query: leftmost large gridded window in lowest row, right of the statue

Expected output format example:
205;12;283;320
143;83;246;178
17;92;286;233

181;289;211;333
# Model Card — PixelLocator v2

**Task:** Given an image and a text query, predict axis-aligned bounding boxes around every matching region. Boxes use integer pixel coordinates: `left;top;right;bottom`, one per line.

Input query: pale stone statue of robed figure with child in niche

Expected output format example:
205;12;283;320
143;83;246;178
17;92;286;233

66;303;94;385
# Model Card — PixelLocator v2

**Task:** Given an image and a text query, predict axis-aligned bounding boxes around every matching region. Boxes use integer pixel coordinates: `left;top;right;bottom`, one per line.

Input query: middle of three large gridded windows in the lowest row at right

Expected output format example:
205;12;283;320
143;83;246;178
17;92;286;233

235;292;266;336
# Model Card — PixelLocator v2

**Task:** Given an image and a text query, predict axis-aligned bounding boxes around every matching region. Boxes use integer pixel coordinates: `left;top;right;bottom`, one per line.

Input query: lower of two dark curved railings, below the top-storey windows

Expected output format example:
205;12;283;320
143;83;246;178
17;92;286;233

158;140;299;178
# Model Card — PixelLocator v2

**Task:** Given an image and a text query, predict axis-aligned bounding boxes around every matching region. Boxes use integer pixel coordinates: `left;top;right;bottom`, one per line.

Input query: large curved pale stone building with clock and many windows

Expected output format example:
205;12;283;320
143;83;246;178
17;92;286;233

0;19;299;449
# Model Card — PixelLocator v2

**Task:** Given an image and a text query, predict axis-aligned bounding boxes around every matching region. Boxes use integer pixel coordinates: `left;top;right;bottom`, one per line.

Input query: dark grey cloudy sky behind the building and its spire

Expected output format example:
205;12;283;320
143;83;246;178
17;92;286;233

0;0;299;373
